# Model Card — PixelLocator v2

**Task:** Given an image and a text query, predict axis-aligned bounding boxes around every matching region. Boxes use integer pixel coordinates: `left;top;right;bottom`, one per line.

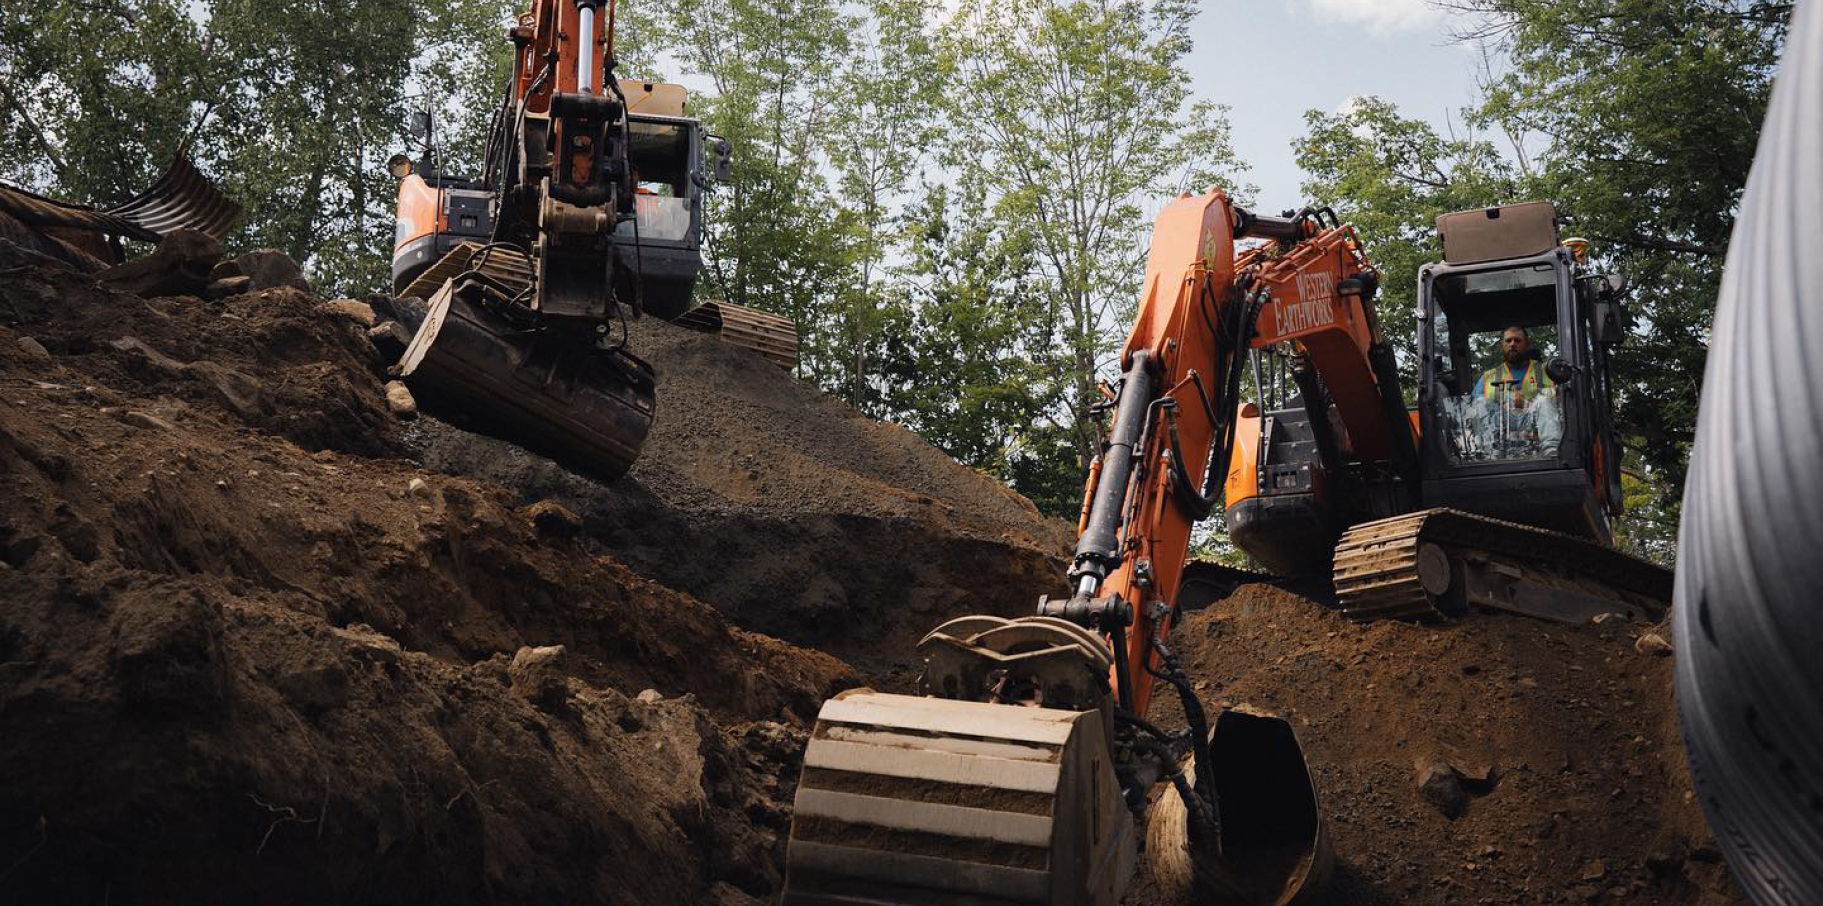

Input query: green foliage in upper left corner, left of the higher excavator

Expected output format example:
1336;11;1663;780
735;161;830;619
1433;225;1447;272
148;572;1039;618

0;0;510;292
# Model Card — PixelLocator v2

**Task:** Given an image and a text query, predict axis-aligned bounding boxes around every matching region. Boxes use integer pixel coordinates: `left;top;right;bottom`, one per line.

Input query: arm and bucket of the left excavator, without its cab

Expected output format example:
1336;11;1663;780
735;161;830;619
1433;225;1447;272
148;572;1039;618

394;0;656;479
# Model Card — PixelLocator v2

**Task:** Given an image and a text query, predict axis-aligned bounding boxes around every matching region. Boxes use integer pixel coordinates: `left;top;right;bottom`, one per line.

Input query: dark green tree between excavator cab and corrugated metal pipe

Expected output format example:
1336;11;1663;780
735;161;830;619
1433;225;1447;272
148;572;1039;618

1444;0;1792;523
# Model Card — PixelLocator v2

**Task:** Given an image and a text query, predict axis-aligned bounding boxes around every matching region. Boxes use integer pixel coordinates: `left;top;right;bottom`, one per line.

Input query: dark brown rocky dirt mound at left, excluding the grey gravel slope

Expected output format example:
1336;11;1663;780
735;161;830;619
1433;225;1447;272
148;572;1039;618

0;248;855;902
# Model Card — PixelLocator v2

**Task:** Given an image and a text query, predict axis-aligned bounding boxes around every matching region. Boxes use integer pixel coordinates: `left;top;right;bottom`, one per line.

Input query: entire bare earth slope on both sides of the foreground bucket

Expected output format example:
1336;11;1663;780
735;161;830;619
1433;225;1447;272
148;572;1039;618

0;242;1743;904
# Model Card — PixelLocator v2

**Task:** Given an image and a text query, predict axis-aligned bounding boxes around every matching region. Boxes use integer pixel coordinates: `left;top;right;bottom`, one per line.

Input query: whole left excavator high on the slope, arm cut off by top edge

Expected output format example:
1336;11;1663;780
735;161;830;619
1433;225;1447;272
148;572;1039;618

390;0;797;479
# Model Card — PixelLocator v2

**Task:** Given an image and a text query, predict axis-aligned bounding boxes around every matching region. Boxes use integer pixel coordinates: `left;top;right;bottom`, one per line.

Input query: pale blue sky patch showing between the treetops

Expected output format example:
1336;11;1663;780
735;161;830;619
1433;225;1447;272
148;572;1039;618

1189;0;1480;213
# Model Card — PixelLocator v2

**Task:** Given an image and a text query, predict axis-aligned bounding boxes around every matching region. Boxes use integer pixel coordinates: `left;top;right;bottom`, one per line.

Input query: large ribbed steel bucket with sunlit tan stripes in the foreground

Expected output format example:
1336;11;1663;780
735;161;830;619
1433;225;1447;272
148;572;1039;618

782;689;1136;906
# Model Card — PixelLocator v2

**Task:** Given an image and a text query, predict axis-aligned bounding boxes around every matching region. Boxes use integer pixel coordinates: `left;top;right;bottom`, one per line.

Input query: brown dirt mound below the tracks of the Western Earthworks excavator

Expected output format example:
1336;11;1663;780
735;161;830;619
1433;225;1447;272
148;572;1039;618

1132;585;1746;906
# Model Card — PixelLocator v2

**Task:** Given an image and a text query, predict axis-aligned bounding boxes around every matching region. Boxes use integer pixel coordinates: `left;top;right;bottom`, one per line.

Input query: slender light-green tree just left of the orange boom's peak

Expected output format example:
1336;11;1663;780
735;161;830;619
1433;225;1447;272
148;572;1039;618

946;0;1240;476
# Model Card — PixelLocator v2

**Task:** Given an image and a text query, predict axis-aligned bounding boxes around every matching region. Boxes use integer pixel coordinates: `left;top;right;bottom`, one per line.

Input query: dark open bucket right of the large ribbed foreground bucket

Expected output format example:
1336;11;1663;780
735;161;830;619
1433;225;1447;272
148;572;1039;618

1147;709;1334;906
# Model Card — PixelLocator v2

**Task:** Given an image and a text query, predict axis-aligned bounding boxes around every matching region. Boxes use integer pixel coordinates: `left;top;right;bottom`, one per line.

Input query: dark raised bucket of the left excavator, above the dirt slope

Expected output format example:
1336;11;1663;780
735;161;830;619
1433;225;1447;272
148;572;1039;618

397;273;654;481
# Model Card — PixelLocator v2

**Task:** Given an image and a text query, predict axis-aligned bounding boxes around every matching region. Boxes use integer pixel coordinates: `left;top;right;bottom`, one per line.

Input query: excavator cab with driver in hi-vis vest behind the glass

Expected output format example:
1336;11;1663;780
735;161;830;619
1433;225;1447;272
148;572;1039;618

1418;202;1624;543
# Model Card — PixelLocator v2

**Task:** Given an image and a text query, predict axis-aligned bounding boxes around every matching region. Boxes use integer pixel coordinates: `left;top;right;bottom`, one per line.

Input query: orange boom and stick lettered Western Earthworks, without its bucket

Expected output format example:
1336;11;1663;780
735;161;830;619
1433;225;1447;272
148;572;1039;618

1041;191;1392;716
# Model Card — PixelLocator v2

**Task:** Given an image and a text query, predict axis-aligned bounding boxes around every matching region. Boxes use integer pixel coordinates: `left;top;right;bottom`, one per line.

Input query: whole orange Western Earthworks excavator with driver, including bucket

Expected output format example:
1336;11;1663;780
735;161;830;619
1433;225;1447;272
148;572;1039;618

784;190;1670;906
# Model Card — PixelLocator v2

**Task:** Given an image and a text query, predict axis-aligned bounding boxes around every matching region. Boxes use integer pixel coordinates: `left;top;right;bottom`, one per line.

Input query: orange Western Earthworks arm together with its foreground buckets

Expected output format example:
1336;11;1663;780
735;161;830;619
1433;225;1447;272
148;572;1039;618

784;191;1378;904
